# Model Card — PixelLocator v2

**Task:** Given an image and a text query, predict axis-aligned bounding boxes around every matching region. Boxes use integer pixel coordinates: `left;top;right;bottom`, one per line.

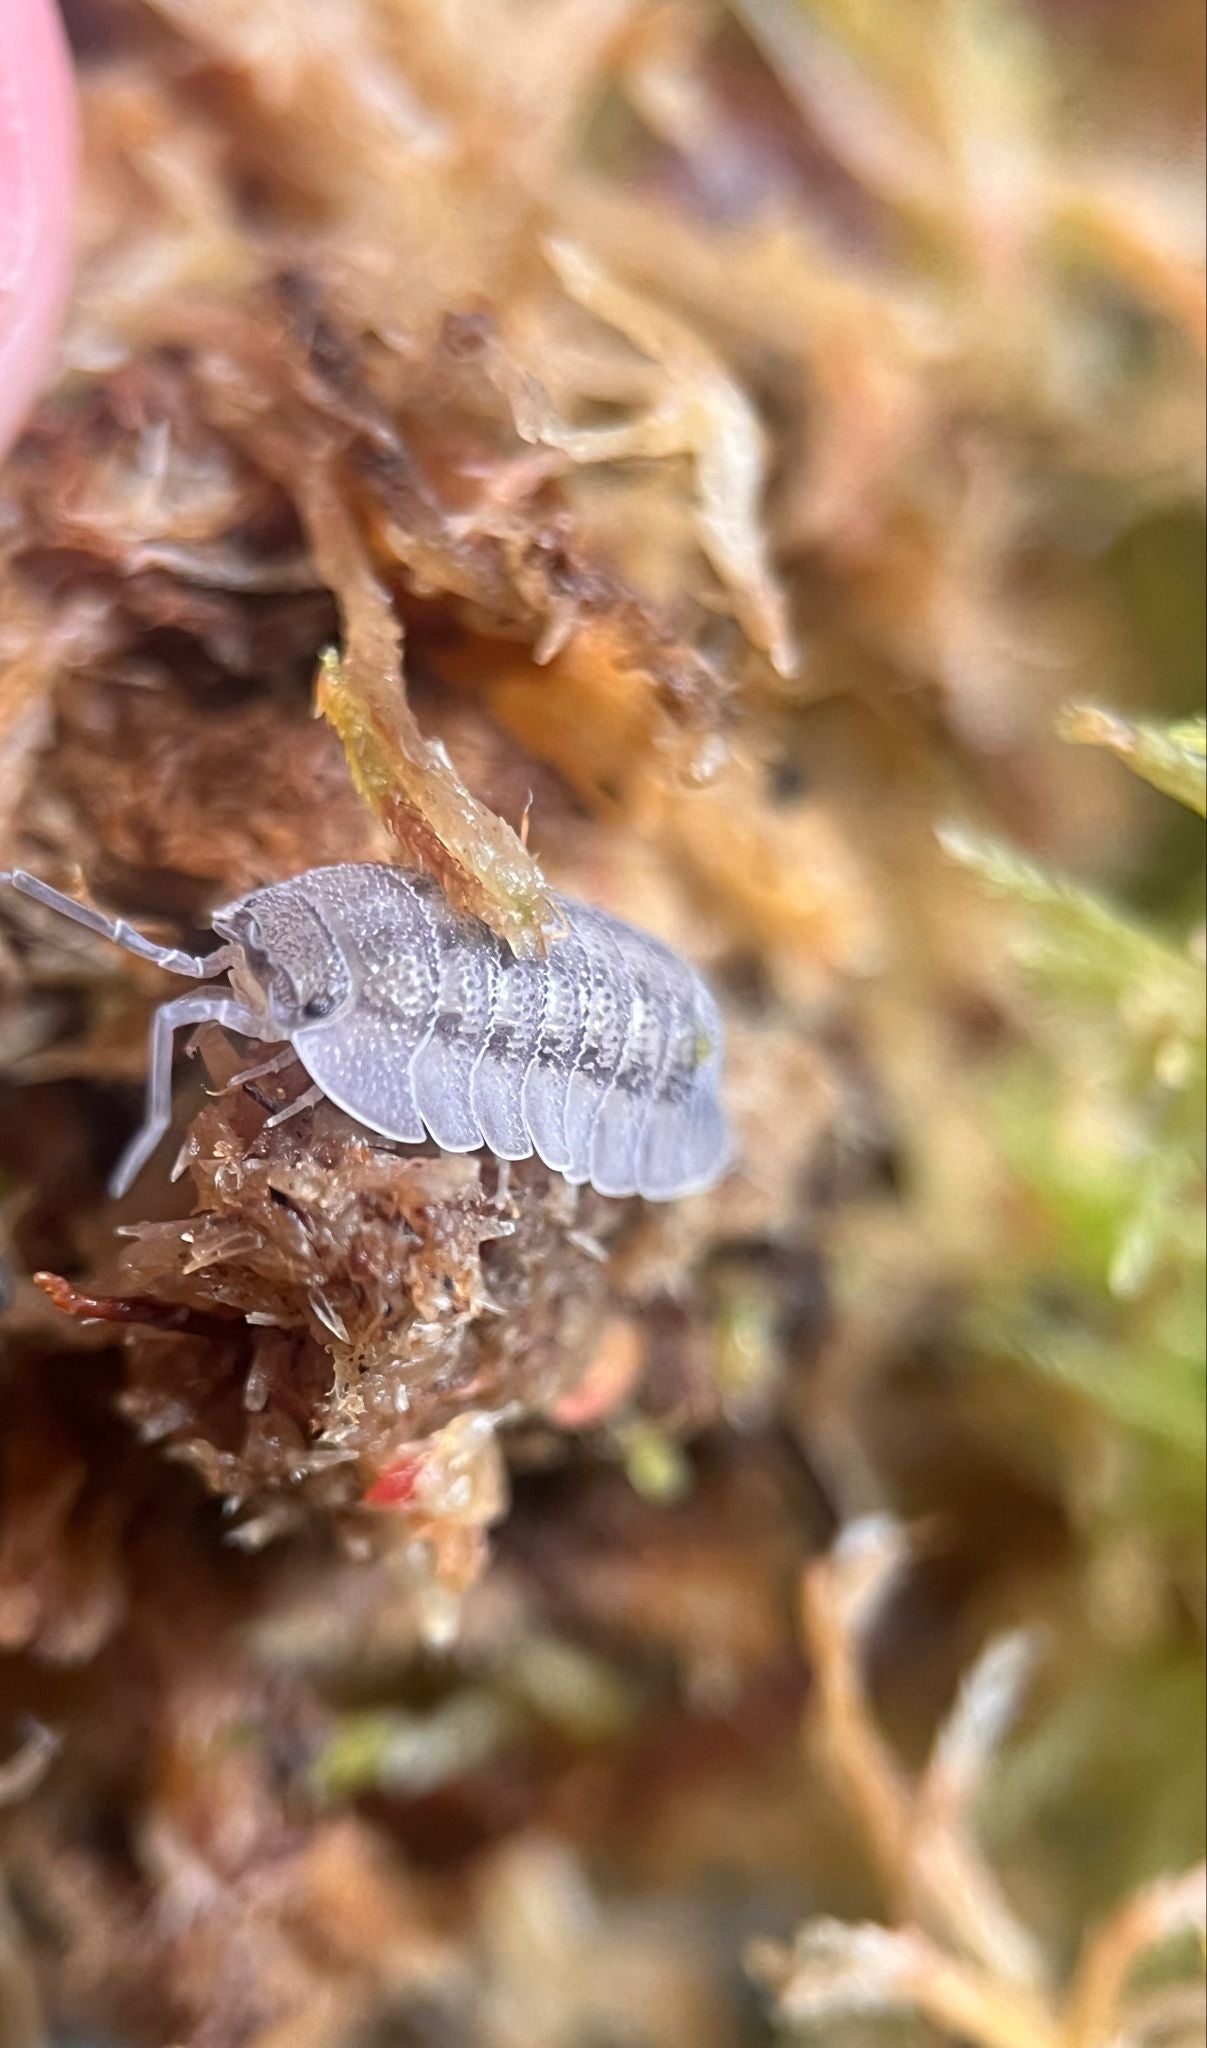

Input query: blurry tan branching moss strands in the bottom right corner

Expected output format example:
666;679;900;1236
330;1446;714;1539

752;1524;1207;2048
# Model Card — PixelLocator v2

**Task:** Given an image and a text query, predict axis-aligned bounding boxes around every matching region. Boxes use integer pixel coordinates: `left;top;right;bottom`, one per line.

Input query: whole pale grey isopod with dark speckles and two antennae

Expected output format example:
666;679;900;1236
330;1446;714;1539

0;862;730;1202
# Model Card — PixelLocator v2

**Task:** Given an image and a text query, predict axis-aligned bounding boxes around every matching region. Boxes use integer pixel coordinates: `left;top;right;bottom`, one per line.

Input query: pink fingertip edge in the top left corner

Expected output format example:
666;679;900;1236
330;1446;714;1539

0;0;76;451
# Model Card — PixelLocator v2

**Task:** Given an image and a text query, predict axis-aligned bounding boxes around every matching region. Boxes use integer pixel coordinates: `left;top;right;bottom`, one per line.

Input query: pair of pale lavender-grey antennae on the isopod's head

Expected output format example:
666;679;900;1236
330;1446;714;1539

0;868;273;1198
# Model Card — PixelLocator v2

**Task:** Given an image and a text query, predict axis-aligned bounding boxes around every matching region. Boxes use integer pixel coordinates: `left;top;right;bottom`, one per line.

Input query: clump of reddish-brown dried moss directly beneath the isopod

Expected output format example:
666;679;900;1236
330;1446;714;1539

23;1007;836;1630
